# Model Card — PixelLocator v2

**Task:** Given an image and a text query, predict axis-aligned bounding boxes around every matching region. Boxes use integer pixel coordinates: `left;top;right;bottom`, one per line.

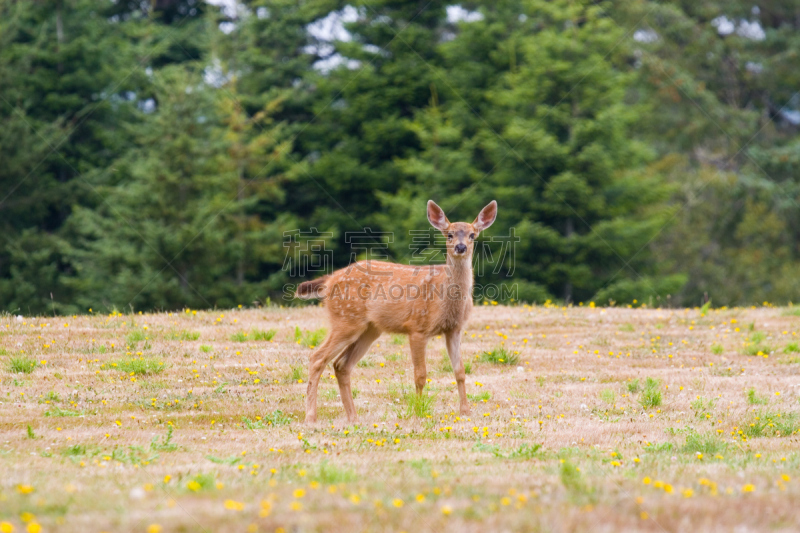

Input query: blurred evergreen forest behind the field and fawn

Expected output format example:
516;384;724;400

0;0;800;314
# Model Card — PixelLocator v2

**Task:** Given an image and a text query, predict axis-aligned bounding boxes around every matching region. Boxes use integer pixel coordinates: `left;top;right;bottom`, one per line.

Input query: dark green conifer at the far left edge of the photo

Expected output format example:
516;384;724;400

0;0;141;313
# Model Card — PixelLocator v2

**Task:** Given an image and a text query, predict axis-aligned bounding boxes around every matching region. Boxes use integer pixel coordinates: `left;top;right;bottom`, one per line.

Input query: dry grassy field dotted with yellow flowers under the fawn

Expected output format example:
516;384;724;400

0;306;800;533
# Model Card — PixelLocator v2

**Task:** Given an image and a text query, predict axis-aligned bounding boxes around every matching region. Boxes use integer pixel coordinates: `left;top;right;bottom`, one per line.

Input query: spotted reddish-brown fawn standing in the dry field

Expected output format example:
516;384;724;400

295;200;497;423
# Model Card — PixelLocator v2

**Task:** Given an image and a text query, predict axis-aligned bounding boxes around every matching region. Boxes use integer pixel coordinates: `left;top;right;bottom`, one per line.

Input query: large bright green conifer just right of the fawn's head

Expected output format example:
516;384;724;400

378;2;684;302
